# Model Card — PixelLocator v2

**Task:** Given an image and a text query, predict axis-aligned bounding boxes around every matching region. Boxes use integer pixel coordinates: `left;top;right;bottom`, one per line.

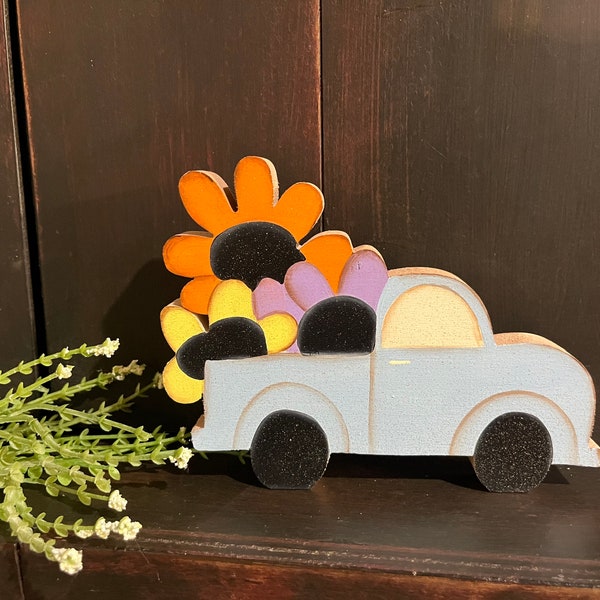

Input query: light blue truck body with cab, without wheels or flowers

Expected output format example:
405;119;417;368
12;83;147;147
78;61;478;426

193;269;600;488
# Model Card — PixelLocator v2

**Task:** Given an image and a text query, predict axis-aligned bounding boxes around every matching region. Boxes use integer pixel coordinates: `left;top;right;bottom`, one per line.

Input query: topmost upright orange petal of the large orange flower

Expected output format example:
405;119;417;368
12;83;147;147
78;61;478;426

234;156;279;223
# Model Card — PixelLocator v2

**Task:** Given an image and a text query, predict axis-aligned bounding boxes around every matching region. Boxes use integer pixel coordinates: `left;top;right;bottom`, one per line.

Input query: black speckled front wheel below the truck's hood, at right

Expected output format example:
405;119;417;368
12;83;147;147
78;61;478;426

473;412;552;492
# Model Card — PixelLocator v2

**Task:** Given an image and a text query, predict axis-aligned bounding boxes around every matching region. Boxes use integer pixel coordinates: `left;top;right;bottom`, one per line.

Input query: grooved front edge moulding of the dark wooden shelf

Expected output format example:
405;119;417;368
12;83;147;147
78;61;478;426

139;529;600;588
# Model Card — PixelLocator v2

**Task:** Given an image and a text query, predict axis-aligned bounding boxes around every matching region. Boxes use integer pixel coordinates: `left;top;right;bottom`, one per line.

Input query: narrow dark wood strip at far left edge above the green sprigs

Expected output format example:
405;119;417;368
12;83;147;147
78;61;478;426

0;1;35;370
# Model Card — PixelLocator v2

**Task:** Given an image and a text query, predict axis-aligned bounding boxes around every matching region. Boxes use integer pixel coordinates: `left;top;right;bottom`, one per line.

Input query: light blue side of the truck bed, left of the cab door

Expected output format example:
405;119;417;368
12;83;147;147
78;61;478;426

192;354;371;453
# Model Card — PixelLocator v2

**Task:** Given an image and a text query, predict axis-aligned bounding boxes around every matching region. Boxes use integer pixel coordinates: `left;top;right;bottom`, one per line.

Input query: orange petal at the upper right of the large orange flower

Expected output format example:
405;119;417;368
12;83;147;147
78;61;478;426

270;182;324;241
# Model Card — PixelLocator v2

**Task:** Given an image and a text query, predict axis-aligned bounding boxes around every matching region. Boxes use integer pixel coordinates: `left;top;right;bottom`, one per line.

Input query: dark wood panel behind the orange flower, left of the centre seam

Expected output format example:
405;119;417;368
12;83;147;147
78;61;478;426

18;0;320;376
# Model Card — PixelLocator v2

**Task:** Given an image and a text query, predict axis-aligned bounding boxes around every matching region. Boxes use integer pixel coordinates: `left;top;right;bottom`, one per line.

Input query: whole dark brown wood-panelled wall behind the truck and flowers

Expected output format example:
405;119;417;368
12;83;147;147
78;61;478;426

0;0;600;597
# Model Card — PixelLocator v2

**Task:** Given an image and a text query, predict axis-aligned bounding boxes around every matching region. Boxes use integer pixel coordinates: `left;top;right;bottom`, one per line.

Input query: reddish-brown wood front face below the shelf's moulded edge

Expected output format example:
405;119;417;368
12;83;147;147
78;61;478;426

18;550;600;600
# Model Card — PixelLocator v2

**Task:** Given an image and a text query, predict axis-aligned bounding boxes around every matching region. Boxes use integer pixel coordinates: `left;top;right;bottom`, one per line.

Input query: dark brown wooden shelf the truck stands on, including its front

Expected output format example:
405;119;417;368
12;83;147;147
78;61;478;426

0;456;600;600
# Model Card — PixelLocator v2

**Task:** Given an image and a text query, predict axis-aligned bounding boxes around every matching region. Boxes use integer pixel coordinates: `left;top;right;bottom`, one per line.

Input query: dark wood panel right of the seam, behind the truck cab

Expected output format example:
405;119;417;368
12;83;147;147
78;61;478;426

322;0;600;432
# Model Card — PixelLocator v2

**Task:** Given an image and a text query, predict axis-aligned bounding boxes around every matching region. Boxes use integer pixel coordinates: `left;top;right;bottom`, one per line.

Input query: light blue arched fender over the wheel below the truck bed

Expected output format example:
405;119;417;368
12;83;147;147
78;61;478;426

233;383;350;452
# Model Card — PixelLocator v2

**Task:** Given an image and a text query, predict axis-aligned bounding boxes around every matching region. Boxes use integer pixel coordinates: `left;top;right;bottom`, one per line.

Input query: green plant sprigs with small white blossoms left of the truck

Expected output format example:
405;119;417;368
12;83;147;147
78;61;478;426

0;339;192;574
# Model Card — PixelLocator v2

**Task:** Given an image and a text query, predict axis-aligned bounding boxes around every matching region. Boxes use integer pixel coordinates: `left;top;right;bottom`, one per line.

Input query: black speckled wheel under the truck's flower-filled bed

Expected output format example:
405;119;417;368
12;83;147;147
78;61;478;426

250;410;329;490
